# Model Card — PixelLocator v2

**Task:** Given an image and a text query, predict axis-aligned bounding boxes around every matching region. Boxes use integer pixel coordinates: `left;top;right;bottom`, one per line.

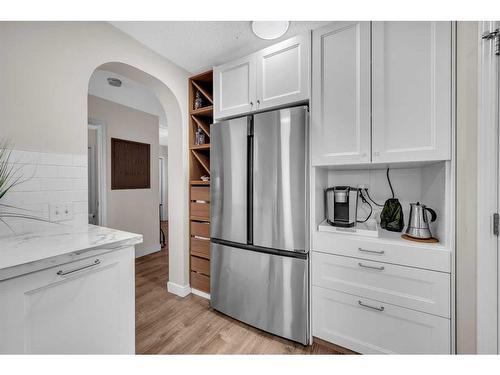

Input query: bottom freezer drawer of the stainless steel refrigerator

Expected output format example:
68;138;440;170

210;243;309;345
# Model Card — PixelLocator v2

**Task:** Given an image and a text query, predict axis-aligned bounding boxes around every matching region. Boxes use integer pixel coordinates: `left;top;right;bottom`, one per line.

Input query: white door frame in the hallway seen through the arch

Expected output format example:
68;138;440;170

88;119;108;227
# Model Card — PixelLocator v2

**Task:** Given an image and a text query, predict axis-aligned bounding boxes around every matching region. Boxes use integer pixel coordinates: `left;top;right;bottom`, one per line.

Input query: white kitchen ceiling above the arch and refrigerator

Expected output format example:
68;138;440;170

111;21;328;73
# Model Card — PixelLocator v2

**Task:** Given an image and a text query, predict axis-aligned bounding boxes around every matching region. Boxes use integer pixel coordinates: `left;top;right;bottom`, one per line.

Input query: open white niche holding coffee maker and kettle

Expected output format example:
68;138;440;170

311;161;452;249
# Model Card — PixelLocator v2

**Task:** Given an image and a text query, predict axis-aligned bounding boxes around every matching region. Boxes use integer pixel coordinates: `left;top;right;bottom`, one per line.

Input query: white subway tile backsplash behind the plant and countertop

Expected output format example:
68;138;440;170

0;150;88;236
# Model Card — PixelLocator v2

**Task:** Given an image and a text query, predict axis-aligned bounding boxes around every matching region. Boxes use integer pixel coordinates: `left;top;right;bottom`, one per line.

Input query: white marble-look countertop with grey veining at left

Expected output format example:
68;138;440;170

0;224;142;280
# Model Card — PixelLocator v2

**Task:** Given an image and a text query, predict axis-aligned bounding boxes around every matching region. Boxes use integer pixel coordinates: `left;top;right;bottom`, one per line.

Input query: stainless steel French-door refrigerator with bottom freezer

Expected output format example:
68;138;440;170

210;106;309;344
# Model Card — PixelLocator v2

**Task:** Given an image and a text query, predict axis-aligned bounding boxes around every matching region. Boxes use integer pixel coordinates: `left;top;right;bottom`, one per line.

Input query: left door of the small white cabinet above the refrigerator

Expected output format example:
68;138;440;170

214;55;256;119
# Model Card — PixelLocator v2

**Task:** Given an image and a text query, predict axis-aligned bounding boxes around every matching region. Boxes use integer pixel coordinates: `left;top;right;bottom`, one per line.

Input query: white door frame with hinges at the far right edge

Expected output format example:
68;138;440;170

471;21;500;354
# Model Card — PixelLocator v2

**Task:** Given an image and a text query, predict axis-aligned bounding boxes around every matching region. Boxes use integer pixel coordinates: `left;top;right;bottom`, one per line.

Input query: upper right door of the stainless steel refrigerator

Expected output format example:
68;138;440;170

253;107;308;251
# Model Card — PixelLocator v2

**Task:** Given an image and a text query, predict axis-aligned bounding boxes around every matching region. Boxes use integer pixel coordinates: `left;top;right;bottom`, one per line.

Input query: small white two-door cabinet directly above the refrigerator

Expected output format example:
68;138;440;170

214;32;311;119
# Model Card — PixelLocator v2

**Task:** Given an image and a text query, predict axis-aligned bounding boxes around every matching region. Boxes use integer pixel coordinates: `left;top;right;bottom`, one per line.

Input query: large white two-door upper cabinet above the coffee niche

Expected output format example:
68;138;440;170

311;22;452;165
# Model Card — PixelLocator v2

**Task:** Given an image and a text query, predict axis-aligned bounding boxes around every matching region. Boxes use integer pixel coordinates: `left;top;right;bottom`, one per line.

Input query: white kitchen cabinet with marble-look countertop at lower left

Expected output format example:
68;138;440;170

0;225;142;354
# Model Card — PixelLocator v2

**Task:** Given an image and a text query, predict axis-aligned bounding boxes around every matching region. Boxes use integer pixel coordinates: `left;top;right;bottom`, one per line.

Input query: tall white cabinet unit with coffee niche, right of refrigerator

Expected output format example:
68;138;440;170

310;21;455;354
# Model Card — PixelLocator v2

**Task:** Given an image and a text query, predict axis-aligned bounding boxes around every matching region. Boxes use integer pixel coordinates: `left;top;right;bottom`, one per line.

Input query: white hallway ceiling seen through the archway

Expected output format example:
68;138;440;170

89;70;168;146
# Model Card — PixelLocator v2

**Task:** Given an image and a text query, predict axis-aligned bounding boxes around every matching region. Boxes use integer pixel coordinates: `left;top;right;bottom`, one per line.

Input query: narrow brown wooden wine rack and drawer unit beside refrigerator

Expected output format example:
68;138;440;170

188;71;213;293
